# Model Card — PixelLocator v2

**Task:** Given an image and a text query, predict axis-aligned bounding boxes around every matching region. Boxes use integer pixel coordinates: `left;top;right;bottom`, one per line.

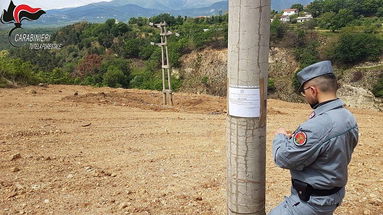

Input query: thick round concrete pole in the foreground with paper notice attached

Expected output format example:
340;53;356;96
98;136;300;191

227;0;270;215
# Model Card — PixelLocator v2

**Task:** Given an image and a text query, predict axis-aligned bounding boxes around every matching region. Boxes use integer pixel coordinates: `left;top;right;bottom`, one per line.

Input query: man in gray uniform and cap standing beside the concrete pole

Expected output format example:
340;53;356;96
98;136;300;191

269;61;358;215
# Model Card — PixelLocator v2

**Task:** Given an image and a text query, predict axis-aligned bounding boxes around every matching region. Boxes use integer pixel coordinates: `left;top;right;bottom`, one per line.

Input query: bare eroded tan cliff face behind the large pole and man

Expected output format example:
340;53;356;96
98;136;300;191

176;47;383;111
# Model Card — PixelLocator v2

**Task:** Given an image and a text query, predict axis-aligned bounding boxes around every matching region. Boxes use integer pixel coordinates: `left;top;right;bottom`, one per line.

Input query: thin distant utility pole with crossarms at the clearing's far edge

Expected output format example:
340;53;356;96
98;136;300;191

149;22;173;105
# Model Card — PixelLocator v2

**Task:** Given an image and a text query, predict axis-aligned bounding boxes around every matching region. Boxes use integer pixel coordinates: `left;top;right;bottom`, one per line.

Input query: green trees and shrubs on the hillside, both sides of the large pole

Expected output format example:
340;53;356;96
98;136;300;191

0;6;383;96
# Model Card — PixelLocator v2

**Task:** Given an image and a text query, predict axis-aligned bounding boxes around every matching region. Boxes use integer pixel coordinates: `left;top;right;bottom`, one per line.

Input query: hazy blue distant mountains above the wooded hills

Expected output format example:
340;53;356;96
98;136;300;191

30;0;312;26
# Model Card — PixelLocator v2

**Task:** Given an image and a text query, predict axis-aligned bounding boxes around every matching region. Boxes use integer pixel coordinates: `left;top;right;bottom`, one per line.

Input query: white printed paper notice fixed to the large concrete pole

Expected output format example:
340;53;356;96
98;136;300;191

229;87;261;118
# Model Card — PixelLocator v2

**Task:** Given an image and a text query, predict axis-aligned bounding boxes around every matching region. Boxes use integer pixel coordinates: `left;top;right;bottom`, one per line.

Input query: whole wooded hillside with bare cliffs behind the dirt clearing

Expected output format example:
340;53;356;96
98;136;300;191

0;0;383;109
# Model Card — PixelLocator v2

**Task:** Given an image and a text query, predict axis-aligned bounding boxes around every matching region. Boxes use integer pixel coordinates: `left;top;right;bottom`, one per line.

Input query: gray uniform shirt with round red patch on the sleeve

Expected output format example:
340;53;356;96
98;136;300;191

273;99;358;205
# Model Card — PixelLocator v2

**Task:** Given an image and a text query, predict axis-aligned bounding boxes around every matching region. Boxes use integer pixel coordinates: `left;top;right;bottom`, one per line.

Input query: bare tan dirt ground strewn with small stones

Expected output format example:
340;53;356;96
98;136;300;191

0;85;383;215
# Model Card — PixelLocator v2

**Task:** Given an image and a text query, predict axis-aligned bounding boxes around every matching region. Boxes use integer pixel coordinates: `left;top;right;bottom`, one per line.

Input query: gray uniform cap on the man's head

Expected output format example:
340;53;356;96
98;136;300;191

297;60;333;91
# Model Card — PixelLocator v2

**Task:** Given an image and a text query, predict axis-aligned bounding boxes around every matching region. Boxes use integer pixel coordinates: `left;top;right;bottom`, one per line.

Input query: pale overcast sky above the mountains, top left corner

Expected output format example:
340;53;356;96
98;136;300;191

0;0;112;13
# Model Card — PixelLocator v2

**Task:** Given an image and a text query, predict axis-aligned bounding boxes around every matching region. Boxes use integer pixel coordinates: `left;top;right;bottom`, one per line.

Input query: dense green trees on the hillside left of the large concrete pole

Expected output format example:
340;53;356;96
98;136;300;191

3;14;227;89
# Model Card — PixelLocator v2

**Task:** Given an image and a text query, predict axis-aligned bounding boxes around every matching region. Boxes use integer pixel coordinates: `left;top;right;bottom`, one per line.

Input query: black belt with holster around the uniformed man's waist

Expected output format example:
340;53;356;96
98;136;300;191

292;179;342;201
